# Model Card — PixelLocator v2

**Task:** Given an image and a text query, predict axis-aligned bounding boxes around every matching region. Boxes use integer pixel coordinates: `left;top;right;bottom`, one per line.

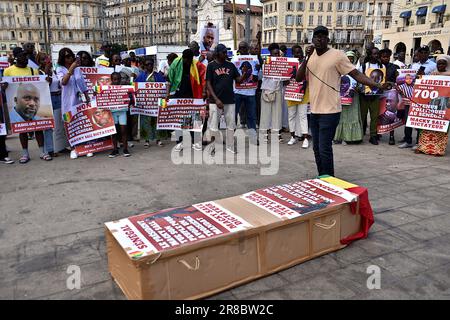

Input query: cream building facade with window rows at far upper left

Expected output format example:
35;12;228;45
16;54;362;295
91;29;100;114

0;0;104;55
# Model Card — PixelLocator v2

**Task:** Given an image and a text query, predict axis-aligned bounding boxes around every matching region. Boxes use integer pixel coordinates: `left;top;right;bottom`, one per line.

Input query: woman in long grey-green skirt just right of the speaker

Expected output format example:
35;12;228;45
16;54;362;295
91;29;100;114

334;51;363;144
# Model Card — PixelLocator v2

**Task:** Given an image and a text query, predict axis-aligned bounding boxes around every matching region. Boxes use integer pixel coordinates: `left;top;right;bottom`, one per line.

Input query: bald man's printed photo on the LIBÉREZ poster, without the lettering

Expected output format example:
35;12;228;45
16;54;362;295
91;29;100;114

9;83;41;123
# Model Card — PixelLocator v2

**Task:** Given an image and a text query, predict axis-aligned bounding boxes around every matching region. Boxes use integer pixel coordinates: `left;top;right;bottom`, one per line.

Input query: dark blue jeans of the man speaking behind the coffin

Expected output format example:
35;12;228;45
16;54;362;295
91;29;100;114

311;113;341;176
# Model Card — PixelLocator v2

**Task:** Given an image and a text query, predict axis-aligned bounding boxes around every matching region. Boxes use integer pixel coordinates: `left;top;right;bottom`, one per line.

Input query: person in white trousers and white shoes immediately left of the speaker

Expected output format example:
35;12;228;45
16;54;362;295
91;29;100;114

286;45;309;149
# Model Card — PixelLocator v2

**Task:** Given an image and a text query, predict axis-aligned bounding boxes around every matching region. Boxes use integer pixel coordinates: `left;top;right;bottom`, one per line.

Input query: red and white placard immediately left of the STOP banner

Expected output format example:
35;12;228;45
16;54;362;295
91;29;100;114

92;85;134;111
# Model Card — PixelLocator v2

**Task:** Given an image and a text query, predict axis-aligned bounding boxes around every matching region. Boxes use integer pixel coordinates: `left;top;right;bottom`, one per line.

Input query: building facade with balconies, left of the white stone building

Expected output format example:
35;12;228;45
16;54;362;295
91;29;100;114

105;0;198;48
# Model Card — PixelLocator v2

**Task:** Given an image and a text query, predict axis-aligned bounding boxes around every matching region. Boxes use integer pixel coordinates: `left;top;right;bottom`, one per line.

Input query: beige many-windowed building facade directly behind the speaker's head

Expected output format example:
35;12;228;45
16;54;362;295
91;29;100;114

261;0;367;50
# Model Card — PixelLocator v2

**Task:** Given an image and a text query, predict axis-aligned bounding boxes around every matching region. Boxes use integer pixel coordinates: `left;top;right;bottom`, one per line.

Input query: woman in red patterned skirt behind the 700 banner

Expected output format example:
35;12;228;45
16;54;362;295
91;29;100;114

415;54;450;156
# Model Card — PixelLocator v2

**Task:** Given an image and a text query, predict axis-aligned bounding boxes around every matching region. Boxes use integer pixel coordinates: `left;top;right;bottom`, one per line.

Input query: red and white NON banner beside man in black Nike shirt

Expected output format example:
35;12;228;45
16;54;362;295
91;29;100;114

157;98;206;132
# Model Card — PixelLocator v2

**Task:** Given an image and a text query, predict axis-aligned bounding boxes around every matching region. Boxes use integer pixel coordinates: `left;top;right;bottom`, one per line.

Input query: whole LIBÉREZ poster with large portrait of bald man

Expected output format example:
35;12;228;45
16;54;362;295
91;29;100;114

3;76;54;133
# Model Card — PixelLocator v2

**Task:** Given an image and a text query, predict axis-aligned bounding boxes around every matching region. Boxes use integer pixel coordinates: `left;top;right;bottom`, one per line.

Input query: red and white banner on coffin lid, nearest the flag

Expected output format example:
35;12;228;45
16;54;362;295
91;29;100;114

241;179;357;219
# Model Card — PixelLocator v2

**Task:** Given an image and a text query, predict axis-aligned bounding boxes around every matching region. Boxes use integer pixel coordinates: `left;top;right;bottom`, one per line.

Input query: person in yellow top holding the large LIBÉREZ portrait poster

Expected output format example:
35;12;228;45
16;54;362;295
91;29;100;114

2;49;52;164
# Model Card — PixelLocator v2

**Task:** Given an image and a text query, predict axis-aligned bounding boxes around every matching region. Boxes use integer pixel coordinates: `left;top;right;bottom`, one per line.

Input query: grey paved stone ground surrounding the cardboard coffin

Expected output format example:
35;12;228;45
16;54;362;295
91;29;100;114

0;131;450;299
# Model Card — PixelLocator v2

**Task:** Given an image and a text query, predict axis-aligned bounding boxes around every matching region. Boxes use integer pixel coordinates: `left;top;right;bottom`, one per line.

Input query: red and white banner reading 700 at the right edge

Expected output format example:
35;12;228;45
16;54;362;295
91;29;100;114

406;76;450;132
